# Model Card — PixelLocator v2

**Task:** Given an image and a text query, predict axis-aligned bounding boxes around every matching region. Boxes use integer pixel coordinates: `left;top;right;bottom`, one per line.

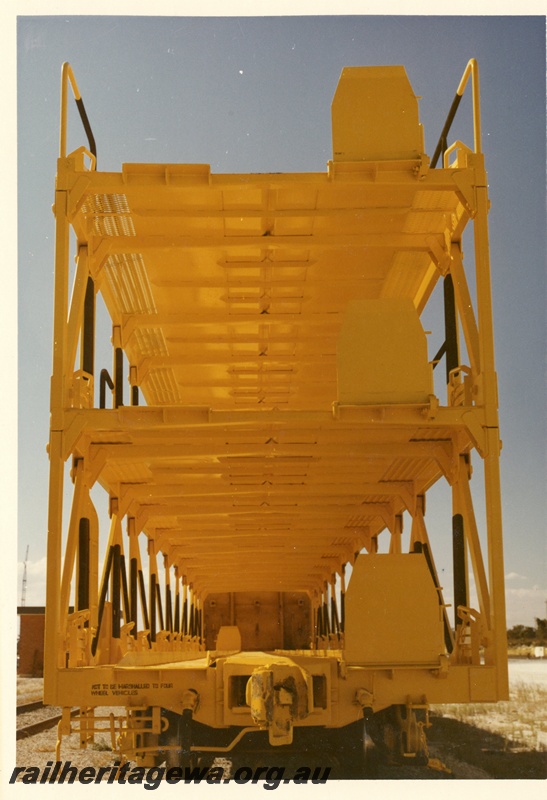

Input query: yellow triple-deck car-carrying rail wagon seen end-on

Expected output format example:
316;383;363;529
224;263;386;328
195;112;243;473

44;61;507;766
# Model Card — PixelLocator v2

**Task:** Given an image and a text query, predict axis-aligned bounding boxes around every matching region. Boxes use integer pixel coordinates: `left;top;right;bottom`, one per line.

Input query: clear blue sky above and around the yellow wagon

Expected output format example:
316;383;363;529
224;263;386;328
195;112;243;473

4;6;547;625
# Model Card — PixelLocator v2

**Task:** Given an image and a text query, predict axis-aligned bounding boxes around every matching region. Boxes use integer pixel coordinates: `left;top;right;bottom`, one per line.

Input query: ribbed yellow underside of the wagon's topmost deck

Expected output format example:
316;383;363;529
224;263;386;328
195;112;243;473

67;161;468;410
